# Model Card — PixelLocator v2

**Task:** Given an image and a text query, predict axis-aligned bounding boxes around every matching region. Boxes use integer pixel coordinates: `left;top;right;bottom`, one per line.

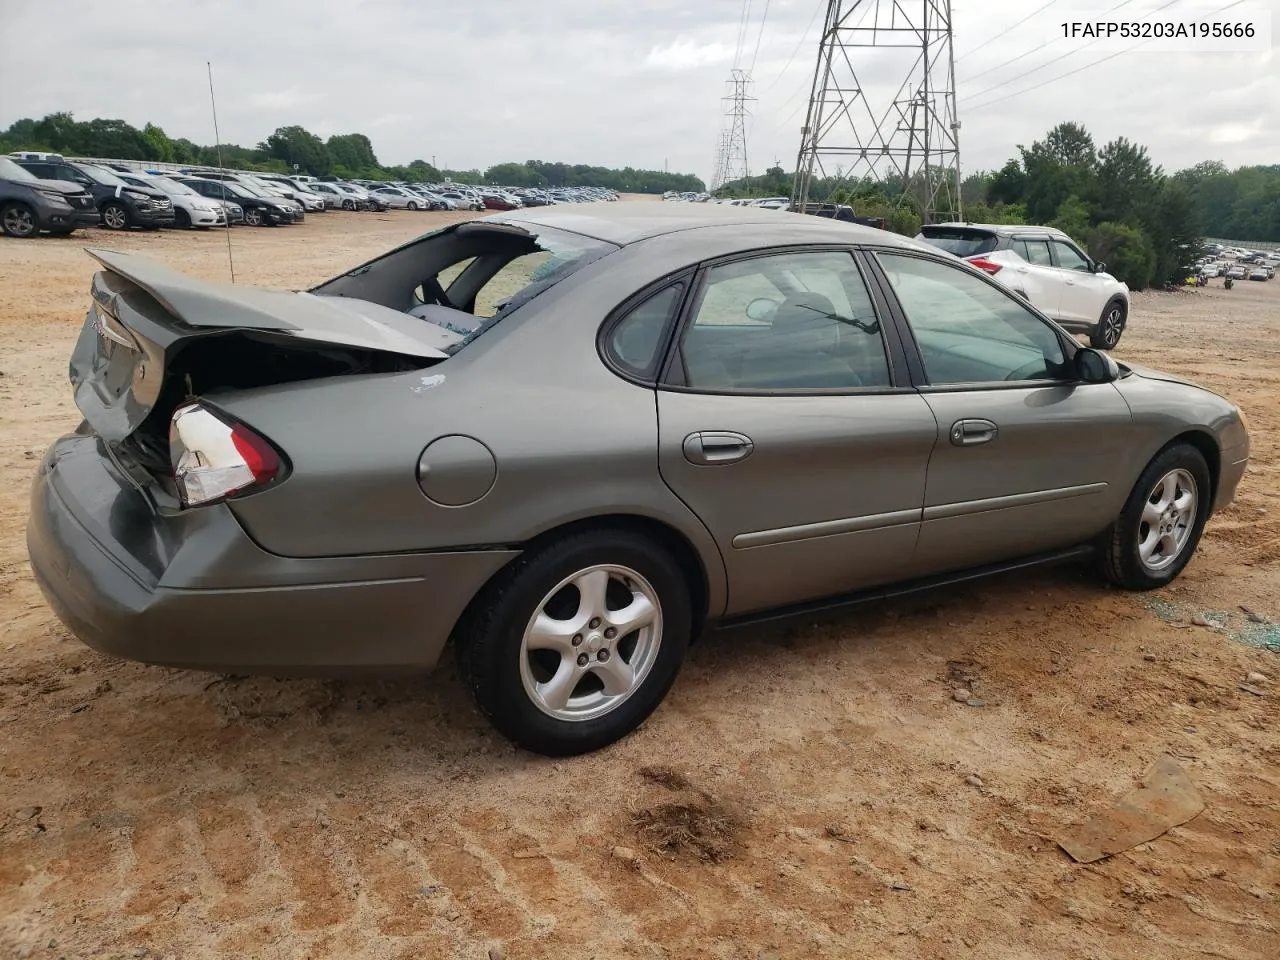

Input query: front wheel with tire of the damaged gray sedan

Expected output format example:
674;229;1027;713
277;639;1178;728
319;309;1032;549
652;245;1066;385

1102;443;1213;590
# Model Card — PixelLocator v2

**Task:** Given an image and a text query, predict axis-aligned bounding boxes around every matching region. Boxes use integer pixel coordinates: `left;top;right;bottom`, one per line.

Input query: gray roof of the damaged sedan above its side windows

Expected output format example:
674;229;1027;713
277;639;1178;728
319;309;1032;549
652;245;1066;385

485;201;922;250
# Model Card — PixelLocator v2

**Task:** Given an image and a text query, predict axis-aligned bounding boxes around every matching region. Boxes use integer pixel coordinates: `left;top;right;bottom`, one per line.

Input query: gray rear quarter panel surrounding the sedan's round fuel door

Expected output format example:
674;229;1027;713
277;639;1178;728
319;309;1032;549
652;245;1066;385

216;244;752;614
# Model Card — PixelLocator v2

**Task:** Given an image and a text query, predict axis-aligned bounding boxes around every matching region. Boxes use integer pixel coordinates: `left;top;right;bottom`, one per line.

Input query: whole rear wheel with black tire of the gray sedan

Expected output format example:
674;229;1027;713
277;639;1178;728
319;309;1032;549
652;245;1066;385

454;530;692;756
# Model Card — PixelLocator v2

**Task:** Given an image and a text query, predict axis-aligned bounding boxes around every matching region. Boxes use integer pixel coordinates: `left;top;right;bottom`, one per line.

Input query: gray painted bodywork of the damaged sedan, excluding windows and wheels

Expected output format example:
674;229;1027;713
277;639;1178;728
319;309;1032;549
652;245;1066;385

28;204;1248;669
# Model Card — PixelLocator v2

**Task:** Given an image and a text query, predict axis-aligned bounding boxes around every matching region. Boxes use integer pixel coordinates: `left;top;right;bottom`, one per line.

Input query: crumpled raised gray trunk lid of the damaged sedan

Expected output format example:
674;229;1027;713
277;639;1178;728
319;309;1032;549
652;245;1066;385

70;252;447;480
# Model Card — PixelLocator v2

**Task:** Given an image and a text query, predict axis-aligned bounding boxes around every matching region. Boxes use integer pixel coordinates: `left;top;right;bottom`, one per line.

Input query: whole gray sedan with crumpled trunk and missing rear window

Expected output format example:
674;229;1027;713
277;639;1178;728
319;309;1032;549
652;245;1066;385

27;204;1249;754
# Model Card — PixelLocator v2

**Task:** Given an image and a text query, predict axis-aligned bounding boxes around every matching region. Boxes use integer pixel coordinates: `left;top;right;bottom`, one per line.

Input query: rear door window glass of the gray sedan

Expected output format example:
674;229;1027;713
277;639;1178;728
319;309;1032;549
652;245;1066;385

681;251;892;393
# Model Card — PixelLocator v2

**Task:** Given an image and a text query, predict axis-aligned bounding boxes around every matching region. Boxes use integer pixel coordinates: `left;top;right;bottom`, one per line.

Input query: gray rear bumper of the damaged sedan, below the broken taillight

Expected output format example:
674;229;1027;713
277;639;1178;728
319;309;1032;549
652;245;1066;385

27;435;517;675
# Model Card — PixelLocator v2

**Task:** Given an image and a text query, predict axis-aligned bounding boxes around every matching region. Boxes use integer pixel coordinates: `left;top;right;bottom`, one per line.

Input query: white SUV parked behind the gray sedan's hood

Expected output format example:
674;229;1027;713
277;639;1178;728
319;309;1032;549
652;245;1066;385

916;223;1129;349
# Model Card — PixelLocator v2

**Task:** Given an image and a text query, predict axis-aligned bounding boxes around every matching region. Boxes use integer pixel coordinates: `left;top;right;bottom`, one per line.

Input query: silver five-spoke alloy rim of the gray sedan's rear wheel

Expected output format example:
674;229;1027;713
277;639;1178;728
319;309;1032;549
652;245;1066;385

520;564;662;721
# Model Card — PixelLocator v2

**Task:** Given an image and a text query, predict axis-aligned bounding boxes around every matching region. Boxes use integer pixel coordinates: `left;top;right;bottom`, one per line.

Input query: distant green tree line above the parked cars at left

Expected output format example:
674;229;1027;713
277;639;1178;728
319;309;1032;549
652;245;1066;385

0;113;704;193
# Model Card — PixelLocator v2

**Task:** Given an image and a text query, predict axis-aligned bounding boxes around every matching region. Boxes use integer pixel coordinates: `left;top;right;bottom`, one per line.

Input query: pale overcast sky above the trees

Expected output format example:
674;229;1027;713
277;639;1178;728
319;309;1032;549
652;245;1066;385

0;0;1280;178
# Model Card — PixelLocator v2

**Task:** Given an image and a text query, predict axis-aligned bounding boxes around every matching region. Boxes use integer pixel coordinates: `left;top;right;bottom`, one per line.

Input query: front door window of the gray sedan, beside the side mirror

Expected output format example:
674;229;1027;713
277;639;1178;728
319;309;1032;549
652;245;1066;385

878;253;1066;385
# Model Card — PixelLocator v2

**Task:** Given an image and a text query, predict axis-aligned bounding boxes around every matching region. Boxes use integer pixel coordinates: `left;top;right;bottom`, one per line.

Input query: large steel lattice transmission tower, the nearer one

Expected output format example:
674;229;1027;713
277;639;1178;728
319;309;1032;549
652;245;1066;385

791;0;963;223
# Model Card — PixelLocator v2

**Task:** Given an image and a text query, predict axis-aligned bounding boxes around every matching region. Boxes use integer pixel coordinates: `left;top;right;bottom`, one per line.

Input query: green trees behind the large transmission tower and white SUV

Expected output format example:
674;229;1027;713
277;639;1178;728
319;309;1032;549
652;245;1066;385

718;123;1280;289
